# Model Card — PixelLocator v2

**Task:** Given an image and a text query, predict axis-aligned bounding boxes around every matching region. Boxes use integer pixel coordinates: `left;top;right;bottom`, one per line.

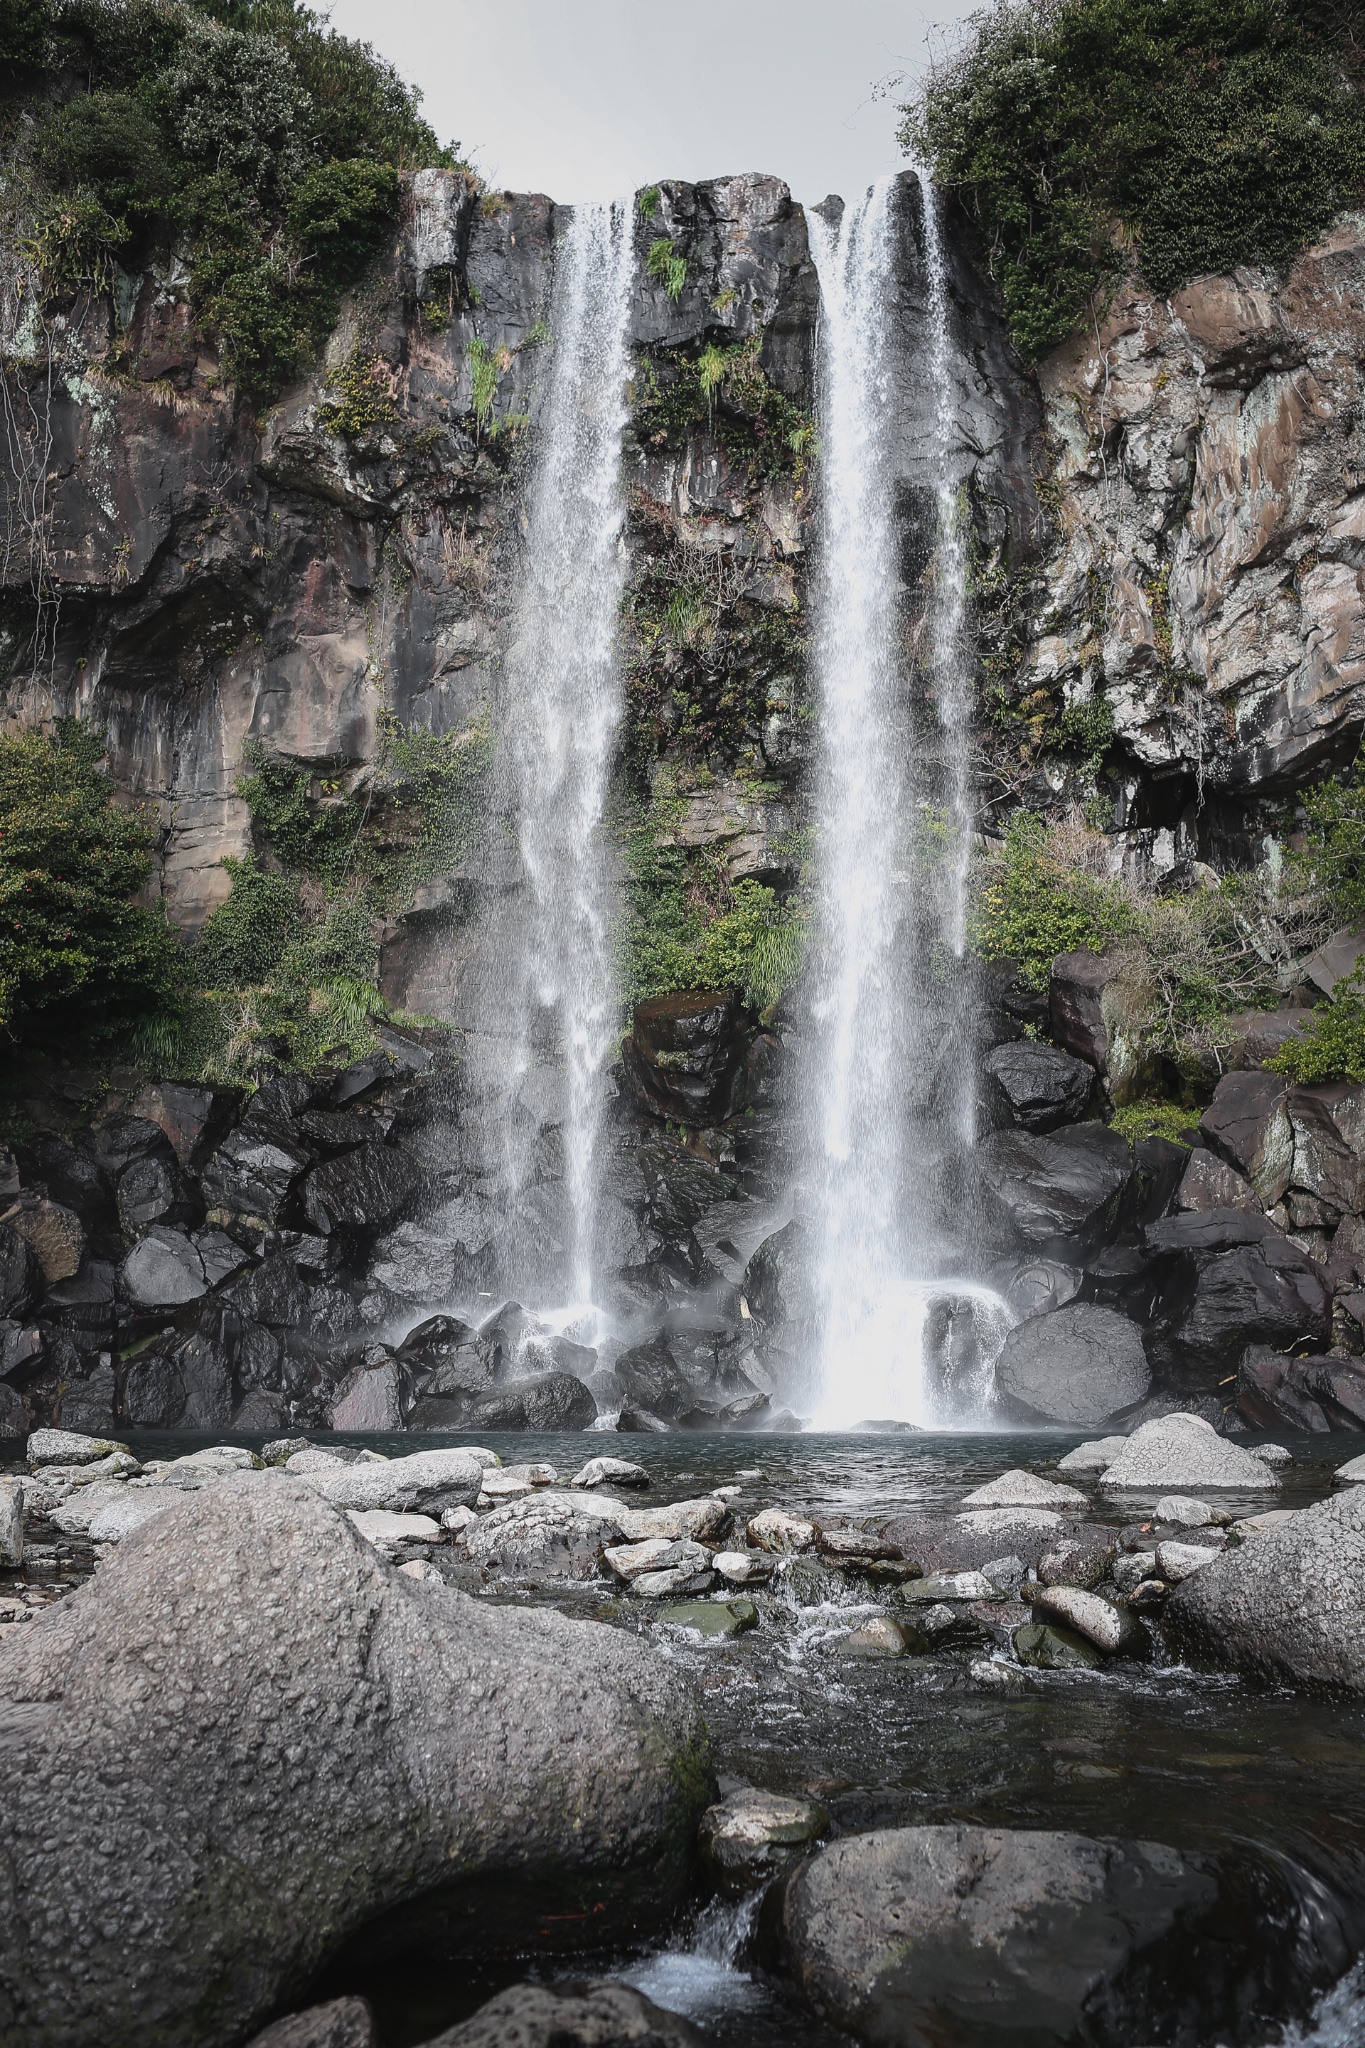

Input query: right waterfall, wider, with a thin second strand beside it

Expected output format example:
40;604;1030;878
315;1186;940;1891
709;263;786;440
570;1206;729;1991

806;178;1007;1427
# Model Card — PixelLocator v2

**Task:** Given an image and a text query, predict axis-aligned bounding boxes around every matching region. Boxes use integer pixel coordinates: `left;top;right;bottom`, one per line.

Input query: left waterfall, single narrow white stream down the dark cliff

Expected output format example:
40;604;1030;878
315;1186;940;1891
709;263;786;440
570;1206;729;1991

485;203;634;1305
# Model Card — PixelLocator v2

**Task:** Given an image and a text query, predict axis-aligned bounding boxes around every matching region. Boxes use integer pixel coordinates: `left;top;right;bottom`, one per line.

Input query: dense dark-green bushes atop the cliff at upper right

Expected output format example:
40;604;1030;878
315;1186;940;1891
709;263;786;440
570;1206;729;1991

902;0;1365;356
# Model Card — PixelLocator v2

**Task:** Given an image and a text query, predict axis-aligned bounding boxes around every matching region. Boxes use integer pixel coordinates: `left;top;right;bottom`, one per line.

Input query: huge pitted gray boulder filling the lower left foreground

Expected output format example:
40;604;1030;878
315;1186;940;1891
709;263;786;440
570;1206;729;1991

0;1473;714;2048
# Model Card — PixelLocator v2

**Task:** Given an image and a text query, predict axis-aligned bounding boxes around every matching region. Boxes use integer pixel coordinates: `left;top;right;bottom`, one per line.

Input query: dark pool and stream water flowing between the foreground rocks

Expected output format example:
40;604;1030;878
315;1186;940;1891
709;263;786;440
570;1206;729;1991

139;1434;1365;2048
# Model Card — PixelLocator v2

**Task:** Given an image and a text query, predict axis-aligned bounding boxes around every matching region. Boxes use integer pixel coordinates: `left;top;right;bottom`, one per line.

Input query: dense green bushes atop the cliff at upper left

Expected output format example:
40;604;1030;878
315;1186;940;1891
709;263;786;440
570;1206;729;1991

0;0;456;401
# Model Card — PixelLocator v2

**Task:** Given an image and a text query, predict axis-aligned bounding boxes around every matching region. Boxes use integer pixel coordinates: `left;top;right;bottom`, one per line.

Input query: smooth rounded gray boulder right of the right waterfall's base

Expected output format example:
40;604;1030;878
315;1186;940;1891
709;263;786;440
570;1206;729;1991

995;1303;1152;1430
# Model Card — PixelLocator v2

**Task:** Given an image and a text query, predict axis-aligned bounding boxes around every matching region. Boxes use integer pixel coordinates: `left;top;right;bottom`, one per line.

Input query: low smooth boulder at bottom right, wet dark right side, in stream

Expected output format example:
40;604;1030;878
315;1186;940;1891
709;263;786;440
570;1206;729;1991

782;1826;1218;2048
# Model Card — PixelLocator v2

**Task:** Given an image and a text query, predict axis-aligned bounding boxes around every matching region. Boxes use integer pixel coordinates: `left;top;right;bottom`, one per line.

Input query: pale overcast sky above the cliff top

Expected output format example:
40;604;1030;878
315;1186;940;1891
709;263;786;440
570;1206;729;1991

329;0;978;201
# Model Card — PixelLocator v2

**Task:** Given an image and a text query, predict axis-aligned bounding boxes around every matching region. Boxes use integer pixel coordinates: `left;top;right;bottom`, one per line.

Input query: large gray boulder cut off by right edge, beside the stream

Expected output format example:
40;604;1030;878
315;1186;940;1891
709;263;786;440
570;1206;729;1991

1164;1487;1365;1692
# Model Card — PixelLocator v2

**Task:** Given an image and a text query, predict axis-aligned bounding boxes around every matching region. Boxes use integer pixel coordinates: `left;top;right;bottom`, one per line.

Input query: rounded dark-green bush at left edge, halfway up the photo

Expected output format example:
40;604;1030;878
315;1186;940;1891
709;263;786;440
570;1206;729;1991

0;721;184;1040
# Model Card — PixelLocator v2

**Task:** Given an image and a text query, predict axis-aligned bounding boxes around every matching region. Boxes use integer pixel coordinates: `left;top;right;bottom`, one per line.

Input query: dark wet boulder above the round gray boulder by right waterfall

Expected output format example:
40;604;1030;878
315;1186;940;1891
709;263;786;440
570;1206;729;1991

976;1122;1134;1260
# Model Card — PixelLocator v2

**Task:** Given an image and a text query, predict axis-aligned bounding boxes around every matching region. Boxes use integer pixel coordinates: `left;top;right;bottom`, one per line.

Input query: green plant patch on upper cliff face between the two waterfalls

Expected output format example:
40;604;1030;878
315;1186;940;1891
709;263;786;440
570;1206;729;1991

634;334;814;483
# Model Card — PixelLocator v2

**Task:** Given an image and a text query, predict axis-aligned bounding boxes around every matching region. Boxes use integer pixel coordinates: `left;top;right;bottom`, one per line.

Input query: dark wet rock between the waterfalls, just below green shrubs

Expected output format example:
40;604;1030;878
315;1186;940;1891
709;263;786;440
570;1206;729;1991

622;989;751;1128
